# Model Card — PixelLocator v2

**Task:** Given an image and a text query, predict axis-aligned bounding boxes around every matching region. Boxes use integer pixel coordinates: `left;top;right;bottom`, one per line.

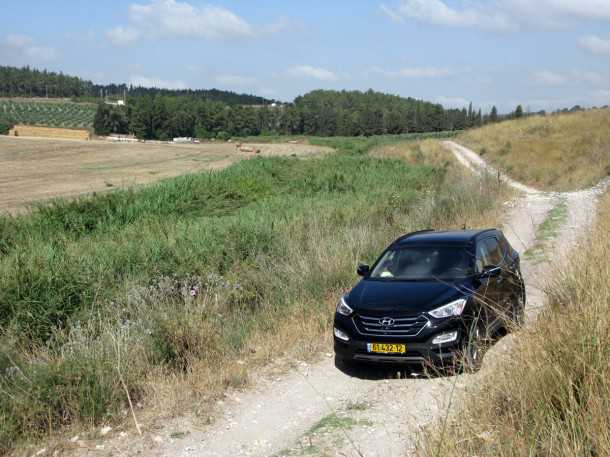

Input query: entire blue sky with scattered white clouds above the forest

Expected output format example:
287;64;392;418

0;0;610;112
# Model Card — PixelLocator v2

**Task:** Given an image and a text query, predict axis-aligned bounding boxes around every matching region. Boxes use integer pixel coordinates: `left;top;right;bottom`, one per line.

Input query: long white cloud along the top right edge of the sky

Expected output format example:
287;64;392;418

381;0;610;31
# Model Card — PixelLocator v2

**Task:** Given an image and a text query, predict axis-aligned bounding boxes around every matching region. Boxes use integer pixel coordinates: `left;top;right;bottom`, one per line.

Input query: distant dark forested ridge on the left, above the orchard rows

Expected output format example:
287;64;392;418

0;66;273;105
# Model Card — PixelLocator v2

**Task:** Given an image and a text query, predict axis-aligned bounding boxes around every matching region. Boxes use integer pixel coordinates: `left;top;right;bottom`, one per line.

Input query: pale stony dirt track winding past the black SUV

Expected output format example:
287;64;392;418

70;141;602;457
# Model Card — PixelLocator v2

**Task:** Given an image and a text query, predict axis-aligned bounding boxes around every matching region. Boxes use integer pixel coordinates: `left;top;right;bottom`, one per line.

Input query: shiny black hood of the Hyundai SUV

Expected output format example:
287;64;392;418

345;279;473;314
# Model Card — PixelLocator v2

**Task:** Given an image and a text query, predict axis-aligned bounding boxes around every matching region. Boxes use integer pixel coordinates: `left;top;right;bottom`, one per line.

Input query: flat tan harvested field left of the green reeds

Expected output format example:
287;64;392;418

0;137;331;213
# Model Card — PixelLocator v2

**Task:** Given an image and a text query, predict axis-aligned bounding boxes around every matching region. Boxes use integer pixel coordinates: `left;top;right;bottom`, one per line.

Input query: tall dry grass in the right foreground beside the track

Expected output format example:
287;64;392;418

422;193;610;457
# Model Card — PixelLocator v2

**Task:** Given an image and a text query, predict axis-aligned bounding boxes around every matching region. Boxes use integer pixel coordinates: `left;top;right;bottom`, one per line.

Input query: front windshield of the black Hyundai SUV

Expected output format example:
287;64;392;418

370;246;473;281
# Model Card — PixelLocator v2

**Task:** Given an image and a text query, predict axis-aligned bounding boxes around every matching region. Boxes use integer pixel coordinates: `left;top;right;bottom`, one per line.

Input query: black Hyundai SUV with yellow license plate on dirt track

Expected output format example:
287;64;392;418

334;229;525;371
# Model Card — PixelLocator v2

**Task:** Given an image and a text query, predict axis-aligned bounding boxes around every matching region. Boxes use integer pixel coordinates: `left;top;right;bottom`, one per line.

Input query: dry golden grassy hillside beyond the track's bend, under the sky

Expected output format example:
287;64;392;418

456;109;610;190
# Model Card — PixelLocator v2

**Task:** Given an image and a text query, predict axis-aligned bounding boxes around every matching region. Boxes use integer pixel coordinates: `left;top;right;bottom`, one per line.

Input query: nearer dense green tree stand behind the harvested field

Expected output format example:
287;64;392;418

94;90;485;140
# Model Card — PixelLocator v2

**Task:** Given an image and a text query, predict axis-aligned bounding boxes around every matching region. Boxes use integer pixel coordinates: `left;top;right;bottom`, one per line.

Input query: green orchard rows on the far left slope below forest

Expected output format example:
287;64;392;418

0;99;97;129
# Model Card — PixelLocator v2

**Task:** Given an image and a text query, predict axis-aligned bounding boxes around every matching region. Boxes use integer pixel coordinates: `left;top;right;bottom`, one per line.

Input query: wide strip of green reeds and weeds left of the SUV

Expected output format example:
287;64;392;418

0;133;501;454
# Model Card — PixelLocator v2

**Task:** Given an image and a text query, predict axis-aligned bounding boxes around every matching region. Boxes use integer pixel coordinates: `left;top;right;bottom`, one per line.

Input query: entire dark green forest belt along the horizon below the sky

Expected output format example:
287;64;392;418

0;66;527;140
